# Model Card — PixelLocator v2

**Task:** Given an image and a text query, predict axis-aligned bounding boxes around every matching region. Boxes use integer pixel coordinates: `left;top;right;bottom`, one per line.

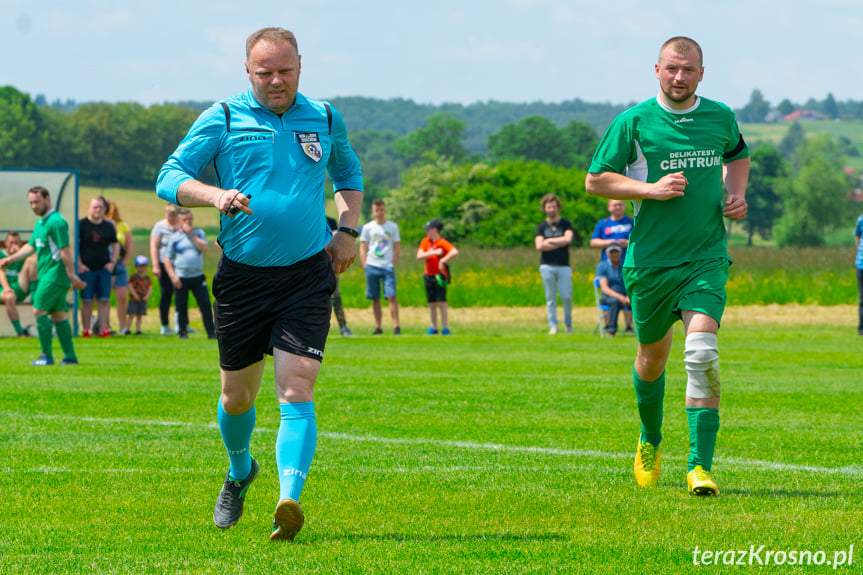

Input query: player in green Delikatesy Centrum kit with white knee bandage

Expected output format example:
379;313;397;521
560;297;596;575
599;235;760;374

585;36;749;495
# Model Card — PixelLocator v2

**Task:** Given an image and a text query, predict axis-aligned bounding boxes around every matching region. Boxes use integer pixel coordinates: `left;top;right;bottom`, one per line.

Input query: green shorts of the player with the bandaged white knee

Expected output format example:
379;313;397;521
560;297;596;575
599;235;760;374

623;258;731;344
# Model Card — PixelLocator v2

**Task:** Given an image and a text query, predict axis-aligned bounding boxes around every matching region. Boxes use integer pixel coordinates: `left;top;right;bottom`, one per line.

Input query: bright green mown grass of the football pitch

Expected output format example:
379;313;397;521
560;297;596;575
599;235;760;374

0;316;863;575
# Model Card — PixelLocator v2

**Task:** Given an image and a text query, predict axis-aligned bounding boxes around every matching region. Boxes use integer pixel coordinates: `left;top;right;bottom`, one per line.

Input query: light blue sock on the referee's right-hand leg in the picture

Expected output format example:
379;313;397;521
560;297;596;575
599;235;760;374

276;401;318;503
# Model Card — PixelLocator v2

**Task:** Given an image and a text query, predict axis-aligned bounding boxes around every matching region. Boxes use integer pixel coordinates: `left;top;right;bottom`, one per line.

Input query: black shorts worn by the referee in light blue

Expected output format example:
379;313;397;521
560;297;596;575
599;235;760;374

213;251;336;371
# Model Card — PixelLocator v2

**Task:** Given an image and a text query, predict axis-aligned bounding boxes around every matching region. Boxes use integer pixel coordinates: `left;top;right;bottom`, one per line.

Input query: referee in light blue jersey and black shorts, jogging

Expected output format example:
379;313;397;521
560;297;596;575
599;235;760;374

156;24;363;540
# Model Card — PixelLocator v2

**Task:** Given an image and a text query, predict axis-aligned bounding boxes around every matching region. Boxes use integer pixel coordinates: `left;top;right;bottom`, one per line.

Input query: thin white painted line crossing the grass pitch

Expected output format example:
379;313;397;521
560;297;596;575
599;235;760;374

8;412;863;476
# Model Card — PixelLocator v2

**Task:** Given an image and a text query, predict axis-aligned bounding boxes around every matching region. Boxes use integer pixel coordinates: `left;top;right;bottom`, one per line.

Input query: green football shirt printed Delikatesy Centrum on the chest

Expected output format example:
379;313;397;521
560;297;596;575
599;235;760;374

588;97;749;268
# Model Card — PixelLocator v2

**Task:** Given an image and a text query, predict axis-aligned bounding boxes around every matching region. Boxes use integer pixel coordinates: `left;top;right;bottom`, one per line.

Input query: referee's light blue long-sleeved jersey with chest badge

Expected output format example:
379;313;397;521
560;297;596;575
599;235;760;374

156;89;363;267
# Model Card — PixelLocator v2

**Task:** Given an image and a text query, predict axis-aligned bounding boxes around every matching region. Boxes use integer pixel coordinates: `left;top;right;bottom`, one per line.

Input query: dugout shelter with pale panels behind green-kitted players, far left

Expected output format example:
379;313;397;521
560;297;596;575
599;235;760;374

0;170;78;337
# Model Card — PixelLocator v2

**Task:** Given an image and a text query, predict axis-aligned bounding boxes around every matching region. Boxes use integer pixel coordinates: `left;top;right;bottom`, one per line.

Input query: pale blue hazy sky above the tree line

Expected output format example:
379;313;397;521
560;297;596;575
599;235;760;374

0;0;863;107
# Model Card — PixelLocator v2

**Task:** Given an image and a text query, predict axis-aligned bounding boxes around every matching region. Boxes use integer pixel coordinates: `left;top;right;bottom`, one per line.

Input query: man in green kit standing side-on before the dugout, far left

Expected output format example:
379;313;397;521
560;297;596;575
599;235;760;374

0;186;86;366
